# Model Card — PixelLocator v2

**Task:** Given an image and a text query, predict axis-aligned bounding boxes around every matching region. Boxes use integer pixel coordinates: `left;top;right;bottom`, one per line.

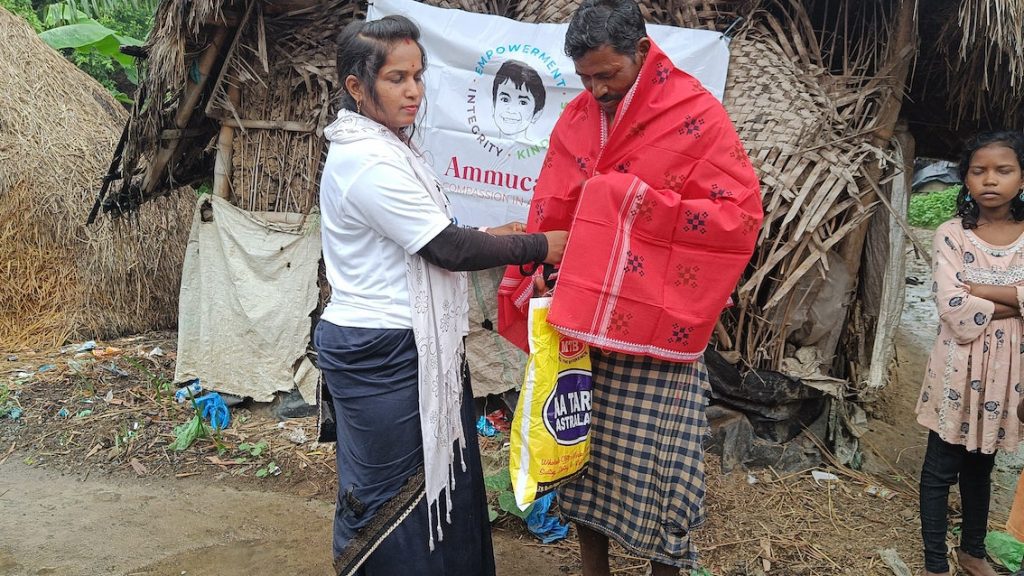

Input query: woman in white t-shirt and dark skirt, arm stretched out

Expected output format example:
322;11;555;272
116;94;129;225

315;16;567;576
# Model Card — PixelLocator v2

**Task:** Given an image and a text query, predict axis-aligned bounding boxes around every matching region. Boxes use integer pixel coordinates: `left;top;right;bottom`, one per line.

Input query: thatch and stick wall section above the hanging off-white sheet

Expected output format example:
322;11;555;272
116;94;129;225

201;0;356;214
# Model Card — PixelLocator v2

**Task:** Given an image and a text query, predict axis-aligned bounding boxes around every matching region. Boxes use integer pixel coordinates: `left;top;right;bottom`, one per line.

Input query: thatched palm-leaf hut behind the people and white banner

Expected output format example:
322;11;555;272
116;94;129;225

86;0;1024;397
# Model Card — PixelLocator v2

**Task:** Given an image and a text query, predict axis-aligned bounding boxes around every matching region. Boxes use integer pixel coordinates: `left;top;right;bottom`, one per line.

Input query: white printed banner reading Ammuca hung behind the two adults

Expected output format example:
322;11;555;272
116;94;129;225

368;0;729;227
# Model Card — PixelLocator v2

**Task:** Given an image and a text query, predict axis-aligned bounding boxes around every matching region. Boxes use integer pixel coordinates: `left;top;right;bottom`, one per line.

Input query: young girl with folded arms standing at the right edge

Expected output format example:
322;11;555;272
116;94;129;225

916;131;1024;576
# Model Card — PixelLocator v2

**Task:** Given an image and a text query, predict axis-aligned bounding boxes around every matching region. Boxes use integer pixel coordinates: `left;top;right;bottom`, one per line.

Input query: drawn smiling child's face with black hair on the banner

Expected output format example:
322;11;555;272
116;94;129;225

492;60;547;138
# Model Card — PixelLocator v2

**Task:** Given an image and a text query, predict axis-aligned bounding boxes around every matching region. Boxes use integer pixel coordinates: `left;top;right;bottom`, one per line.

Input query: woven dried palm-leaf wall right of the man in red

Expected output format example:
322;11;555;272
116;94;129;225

725;19;881;368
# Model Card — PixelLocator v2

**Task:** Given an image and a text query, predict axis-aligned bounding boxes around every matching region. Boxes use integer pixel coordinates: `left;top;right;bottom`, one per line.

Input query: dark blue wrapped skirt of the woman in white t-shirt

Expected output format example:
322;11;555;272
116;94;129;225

314;321;495;576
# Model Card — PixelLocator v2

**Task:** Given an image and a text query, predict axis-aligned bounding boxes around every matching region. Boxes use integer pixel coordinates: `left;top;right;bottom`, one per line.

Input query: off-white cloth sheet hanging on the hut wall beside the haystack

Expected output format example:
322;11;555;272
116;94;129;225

174;196;321;404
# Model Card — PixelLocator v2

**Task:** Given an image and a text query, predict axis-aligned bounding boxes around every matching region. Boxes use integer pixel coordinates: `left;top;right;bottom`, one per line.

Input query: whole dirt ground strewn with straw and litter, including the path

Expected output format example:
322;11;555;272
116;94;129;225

0;229;1016;576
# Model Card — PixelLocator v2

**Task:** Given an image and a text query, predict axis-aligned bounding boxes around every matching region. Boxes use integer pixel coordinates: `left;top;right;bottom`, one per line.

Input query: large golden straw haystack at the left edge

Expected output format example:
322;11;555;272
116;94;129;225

0;8;194;351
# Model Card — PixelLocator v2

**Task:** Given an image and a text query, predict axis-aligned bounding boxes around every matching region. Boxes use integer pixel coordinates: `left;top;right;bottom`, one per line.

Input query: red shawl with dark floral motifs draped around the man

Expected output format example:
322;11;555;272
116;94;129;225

499;43;762;362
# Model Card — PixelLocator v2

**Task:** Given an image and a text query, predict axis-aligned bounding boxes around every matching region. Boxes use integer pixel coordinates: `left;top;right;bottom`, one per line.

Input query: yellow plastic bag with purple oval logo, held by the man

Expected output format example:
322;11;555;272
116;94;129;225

509;298;594;509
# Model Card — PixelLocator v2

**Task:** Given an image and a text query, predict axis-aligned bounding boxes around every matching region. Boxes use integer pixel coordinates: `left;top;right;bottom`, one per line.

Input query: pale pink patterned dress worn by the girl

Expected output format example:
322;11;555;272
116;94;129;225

916;218;1024;454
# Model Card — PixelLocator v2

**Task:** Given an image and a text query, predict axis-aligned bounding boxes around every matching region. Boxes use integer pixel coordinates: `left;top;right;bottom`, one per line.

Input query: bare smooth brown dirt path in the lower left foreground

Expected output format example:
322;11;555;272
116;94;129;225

0;453;561;576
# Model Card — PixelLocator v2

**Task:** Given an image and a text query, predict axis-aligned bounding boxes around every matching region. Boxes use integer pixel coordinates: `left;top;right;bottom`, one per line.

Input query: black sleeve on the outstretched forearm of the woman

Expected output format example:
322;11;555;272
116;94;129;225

418;224;548;272
